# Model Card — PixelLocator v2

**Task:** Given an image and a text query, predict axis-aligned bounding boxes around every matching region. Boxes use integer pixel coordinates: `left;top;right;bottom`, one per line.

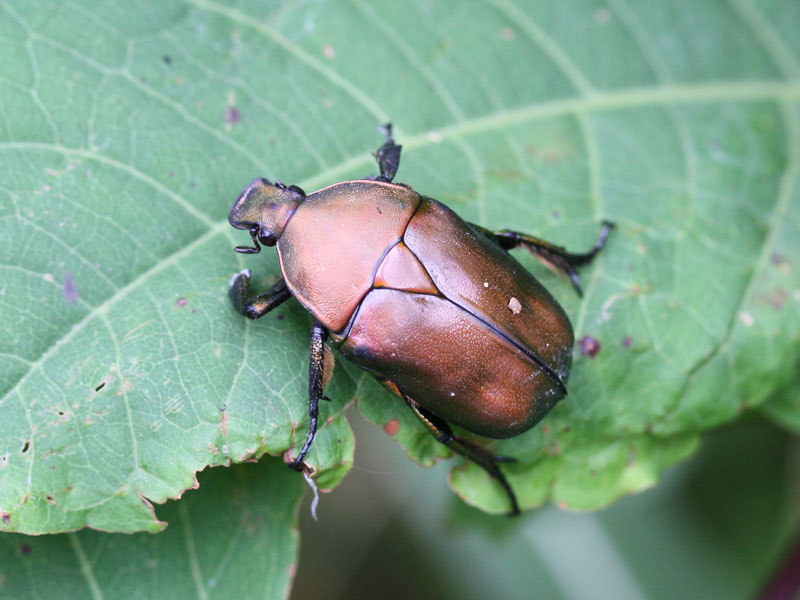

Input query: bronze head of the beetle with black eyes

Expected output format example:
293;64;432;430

228;179;305;254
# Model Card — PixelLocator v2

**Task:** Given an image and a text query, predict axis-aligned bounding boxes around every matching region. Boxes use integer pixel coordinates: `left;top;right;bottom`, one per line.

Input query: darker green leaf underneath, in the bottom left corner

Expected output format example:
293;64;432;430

0;460;304;598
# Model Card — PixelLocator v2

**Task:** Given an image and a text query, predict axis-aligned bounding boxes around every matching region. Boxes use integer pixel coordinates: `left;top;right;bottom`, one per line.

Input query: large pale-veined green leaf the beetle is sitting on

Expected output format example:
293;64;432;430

0;0;800;544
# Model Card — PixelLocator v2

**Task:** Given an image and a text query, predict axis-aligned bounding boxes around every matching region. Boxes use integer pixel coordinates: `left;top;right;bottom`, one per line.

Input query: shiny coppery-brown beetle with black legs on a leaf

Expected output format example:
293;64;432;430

228;124;613;514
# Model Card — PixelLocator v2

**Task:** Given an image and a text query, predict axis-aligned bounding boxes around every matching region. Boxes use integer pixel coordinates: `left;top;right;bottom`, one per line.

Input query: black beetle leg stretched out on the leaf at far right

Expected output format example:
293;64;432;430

473;221;614;296
